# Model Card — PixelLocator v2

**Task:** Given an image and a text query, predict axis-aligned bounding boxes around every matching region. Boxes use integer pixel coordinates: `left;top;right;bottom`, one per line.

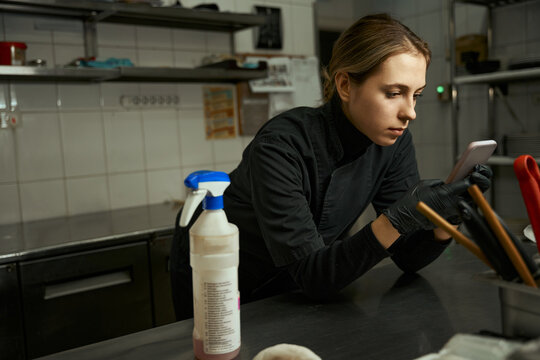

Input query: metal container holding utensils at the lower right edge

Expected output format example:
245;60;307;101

475;271;540;338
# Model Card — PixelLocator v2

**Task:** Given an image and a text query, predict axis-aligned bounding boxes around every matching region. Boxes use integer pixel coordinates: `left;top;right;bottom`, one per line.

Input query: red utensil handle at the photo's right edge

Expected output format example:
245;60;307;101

514;155;540;251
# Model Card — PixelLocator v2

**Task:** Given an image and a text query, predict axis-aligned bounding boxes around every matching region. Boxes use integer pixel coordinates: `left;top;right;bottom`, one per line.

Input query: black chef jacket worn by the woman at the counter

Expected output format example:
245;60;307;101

224;96;446;299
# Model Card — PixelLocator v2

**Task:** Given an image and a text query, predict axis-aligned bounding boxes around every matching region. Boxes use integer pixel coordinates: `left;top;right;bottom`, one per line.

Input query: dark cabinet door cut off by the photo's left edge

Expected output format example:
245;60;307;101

0;264;25;359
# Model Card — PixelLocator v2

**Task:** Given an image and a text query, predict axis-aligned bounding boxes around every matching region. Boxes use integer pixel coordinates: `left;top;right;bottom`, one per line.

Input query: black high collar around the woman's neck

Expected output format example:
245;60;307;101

330;93;373;163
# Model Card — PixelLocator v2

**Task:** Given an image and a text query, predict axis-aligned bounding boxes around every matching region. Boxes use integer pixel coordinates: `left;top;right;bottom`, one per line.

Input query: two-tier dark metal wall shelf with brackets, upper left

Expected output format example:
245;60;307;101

0;0;267;82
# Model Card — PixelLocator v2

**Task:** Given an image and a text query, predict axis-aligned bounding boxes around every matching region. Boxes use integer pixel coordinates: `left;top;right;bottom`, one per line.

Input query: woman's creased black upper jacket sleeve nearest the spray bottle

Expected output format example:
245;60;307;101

249;136;324;266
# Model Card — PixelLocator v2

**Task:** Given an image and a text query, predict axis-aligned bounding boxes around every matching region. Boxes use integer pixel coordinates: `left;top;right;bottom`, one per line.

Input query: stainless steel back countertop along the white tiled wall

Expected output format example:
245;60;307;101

0;204;179;264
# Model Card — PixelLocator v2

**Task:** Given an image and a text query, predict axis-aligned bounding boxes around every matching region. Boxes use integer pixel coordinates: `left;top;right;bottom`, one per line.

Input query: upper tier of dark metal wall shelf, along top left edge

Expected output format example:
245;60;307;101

0;0;266;32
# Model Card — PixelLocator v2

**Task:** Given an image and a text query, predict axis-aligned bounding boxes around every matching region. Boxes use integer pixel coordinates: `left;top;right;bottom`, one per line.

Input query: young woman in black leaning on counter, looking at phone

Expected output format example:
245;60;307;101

171;14;491;319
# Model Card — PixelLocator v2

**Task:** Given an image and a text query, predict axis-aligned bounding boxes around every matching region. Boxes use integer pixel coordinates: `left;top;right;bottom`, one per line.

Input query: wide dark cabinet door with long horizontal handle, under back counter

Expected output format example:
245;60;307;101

20;241;152;358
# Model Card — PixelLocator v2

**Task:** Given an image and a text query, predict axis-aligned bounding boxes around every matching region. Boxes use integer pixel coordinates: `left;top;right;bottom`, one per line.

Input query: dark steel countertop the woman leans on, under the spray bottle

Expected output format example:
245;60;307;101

37;244;501;360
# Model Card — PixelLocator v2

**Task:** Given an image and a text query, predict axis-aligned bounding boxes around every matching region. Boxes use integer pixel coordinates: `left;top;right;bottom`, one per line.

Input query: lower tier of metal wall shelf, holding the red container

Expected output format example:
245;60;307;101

0;66;267;82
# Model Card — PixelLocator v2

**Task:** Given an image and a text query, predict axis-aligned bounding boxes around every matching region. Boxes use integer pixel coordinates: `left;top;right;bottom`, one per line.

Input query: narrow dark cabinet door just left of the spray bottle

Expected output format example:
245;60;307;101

150;234;176;326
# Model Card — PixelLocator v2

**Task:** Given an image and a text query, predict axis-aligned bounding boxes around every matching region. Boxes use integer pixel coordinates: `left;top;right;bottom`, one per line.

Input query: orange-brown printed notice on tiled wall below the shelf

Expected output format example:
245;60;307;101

203;86;236;140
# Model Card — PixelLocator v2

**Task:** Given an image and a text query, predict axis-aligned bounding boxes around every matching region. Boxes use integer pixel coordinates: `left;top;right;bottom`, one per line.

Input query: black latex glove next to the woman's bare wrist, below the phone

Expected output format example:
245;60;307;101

383;178;471;235
